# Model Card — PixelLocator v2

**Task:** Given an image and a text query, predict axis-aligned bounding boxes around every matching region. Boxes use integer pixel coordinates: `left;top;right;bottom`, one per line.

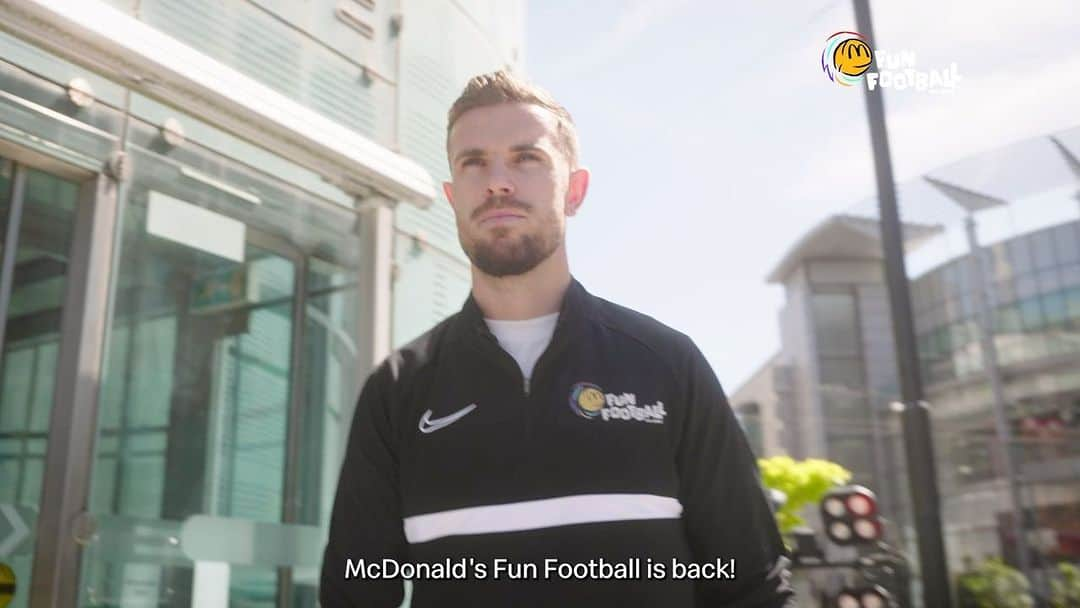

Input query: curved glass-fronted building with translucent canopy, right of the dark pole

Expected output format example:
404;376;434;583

912;199;1080;593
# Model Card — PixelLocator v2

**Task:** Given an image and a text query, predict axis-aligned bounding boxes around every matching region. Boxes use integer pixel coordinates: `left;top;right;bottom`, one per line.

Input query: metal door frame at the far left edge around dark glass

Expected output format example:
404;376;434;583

0;147;117;608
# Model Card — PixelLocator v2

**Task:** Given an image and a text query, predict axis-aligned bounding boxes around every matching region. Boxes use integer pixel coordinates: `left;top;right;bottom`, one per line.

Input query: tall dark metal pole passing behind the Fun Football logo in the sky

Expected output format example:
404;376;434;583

853;0;951;608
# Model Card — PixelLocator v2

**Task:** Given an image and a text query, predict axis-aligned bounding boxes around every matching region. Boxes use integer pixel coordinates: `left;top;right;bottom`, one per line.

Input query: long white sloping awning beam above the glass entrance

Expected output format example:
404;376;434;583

0;0;436;206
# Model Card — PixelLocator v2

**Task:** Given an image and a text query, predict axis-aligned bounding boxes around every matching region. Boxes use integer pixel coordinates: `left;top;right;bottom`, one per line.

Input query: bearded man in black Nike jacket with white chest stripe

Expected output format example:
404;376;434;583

321;72;794;608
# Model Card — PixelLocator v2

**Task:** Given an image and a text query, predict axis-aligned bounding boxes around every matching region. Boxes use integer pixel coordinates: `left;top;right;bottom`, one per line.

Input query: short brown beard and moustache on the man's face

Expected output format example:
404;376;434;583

459;200;563;278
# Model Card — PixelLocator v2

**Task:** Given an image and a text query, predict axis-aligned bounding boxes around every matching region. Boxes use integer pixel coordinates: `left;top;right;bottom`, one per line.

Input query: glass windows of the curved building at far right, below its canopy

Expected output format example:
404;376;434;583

913;221;1080;492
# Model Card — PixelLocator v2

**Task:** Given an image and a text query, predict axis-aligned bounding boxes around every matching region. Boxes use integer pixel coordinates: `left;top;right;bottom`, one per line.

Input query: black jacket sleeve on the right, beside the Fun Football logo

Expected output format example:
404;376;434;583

676;339;797;608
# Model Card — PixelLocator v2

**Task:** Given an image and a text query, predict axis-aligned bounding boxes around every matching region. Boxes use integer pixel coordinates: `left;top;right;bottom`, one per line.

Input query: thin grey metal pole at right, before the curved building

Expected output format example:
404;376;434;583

963;213;1035;584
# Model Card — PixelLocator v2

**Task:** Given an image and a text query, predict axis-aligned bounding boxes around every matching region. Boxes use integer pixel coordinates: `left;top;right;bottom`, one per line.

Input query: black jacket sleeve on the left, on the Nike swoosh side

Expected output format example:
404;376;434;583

319;360;407;608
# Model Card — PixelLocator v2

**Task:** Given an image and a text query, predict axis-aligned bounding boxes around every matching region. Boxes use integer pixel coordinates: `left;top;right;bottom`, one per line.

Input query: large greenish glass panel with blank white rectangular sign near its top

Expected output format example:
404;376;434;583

80;138;368;607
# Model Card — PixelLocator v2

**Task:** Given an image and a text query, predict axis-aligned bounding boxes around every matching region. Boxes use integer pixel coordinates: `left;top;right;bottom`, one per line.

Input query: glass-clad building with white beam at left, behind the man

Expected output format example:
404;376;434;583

0;0;524;608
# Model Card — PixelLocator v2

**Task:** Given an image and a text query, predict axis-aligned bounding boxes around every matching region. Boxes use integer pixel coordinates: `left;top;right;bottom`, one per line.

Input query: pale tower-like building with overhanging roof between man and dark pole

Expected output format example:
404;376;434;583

731;216;937;548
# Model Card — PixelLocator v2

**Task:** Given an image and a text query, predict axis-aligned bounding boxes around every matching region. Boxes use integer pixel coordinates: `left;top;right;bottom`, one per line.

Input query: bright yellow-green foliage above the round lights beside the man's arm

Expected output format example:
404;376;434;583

757;456;851;533
